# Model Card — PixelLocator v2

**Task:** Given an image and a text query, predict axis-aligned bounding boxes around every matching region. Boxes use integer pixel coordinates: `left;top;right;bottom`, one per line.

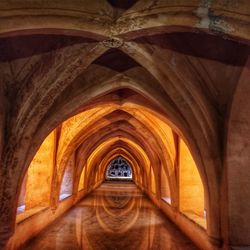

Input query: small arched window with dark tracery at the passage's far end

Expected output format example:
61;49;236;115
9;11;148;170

106;157;132;180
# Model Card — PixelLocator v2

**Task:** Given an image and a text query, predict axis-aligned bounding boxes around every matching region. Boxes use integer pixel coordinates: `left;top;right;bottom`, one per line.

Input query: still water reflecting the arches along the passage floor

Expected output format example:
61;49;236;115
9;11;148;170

23;183;197;250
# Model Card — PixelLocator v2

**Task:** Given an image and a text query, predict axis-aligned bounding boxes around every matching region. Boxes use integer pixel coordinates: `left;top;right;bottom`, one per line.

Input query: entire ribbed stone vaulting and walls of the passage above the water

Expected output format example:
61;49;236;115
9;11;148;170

0;0;250;249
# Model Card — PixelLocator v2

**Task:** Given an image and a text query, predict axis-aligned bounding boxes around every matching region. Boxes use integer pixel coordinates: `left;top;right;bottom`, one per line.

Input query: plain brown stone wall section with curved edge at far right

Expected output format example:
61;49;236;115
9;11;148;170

226;58;250;249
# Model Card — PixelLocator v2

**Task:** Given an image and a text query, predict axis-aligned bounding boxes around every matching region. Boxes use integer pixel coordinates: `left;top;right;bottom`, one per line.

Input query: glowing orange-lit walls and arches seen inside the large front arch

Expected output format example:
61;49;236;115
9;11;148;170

16;99;204;229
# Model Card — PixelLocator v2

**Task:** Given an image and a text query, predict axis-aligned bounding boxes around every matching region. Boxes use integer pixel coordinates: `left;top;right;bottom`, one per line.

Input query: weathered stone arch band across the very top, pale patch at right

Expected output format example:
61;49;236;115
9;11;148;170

0;0;249;39
